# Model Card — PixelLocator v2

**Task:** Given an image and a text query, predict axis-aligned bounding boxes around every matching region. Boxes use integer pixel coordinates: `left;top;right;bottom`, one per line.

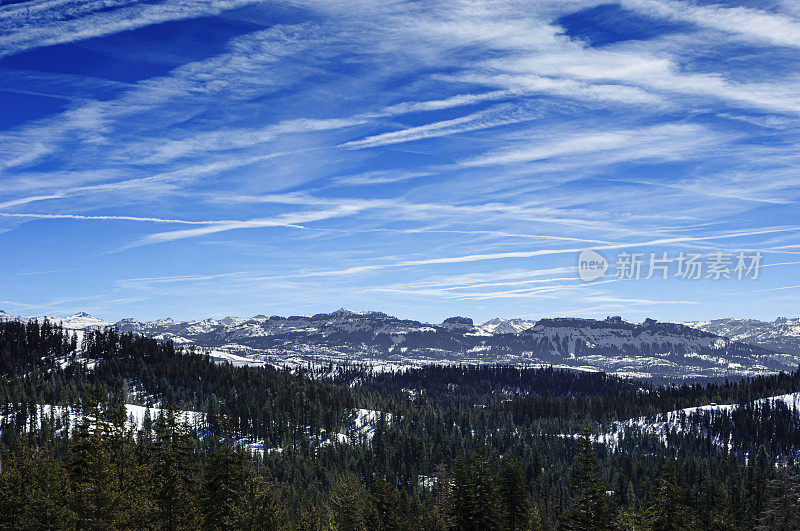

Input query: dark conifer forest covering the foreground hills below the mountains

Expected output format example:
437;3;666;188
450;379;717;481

0;321;800;530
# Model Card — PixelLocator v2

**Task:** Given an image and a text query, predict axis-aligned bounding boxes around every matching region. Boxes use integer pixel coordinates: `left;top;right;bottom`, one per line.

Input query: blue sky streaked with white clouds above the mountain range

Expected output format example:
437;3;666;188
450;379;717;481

0;0;800;321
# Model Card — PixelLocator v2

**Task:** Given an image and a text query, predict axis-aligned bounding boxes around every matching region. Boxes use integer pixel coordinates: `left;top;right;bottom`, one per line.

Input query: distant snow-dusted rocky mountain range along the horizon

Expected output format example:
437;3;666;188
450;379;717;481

0;309;800;378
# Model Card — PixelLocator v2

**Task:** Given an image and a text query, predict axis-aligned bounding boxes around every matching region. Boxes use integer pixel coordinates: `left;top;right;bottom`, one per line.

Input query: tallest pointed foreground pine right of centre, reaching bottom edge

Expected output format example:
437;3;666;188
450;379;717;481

563;426;611;530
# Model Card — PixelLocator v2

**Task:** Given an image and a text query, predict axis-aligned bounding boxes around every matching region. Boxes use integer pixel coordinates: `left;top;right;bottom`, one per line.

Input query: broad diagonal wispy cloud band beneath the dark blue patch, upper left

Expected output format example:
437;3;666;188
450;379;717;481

0;24;322;167
